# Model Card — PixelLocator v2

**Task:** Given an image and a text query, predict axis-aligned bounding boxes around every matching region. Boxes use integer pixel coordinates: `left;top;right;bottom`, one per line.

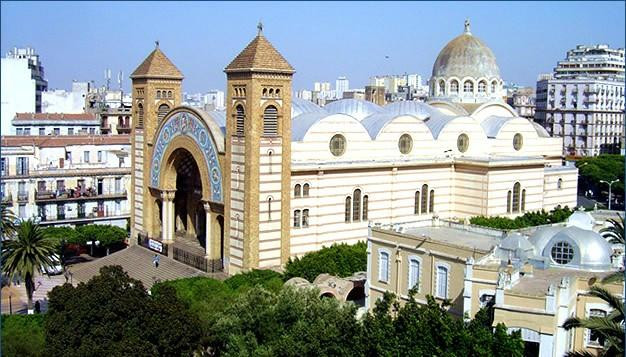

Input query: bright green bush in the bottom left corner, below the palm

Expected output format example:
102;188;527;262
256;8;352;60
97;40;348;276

2;314;45;357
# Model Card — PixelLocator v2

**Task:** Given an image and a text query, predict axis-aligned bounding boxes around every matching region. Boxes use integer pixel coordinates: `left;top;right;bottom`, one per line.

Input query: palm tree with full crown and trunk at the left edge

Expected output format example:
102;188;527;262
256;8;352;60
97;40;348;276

2;220;57;314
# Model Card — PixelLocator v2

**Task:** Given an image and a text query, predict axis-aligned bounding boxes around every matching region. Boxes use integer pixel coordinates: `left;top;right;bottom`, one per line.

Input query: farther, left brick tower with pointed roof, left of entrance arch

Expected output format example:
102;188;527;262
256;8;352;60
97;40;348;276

130;41;183;241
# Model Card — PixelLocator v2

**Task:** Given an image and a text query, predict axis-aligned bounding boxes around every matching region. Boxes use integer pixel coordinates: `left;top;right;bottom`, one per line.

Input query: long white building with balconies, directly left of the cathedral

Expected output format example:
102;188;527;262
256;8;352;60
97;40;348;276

0;135;130;227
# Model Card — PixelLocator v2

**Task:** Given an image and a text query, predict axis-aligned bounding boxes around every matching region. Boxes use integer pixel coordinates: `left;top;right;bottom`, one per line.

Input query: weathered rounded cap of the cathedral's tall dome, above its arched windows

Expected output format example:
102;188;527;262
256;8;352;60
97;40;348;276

432;21;500;79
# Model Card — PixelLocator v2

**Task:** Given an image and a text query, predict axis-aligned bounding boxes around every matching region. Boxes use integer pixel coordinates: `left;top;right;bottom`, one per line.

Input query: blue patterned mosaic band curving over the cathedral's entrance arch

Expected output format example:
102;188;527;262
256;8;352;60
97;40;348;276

150;111;223;202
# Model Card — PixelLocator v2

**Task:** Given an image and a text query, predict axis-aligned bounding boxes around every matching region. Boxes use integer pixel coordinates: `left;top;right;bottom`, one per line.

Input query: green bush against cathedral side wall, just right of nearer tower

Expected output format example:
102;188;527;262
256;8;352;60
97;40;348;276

284;242;367;282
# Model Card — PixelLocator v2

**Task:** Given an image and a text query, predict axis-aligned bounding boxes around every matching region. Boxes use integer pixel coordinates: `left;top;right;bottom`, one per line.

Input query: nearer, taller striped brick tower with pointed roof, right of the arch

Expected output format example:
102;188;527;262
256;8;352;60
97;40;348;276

224;24;295;274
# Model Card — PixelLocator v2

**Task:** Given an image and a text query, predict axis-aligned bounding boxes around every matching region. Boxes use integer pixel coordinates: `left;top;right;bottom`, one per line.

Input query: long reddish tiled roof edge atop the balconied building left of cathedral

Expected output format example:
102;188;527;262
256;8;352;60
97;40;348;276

0;135;130;148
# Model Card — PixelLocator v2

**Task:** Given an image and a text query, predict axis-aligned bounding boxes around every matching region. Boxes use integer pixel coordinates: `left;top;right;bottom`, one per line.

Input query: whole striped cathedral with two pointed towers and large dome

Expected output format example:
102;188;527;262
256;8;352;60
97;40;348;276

131;22;578;274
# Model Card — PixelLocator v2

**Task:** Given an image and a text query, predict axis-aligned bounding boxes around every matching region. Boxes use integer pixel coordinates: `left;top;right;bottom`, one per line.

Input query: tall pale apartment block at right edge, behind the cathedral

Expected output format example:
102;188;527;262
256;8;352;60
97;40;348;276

535;45;624;156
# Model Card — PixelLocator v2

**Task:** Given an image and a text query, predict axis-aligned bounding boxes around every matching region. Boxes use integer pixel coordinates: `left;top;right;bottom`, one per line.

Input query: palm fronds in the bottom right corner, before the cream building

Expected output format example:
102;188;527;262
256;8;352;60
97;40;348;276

563;285;624;357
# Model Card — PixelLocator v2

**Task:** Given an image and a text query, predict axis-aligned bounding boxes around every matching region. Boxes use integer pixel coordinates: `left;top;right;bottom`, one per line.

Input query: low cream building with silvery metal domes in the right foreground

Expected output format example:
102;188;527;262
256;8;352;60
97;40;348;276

366;212;623;357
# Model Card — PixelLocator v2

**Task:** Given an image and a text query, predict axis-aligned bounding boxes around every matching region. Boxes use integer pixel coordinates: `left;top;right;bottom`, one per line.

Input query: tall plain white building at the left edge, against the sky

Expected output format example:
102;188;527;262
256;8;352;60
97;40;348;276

0;48;48;133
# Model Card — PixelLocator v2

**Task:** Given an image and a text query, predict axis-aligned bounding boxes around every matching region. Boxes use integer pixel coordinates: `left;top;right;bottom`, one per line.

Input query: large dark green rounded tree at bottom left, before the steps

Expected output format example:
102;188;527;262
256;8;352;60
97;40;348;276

44;266;201;356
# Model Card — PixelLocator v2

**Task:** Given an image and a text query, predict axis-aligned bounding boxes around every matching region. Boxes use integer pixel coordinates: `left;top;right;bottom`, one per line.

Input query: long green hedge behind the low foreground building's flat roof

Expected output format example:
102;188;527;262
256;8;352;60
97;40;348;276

470;206;574;230
